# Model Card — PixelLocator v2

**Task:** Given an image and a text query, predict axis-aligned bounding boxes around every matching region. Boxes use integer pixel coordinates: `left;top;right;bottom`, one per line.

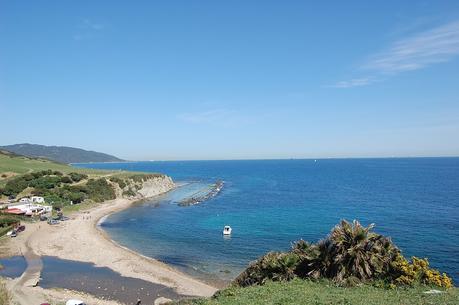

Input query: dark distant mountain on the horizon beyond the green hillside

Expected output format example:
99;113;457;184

0;143;124;163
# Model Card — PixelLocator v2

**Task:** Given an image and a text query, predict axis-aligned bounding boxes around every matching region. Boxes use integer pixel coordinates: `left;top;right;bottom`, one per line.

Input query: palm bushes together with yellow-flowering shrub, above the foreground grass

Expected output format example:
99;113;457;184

234;220;452;288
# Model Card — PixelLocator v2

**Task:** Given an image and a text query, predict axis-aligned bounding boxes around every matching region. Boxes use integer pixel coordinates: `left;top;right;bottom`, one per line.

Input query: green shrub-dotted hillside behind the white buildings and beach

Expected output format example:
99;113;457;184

0;151;163;207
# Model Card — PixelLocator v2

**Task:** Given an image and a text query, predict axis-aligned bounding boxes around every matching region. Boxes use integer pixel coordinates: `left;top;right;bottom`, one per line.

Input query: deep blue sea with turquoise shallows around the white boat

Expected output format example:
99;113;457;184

75;158;459;284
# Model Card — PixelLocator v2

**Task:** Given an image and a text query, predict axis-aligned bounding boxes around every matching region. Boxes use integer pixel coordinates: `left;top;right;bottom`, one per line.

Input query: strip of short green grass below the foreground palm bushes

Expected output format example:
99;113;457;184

178;279;459;305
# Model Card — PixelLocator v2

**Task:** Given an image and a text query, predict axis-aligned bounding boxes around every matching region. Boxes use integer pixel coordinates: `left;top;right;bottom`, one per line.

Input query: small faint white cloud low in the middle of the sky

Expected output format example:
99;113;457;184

177;109;250;127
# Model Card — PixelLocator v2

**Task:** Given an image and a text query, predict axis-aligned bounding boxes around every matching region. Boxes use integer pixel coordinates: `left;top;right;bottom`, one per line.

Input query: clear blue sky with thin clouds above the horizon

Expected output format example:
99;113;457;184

0;0;459;160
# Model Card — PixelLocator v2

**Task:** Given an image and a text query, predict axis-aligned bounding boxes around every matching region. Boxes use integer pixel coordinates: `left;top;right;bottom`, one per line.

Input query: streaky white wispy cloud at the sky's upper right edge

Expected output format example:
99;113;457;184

332;21;459;88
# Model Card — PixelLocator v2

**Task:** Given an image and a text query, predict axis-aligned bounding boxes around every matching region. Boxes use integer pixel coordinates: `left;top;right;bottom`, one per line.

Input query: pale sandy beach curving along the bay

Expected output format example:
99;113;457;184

2;183;217;305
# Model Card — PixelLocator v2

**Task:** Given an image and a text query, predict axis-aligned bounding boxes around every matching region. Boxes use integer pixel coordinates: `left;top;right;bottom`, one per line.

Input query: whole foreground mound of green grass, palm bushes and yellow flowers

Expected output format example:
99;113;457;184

178;220;459;305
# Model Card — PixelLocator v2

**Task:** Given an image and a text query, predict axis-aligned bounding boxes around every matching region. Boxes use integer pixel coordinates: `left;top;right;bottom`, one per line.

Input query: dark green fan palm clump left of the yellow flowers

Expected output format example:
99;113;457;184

234;220;400;286
